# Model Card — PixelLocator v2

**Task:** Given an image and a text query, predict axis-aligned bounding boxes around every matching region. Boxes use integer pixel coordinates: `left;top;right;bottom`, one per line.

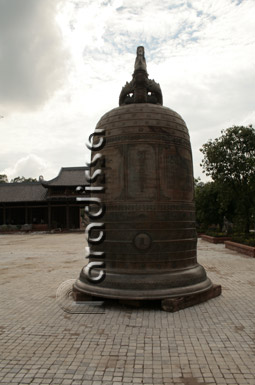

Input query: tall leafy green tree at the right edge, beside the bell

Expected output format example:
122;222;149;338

200;126;255;233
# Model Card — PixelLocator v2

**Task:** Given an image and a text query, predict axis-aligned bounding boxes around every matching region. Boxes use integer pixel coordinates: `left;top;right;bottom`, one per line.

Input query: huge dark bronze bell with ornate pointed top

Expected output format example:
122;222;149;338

74;47;221;311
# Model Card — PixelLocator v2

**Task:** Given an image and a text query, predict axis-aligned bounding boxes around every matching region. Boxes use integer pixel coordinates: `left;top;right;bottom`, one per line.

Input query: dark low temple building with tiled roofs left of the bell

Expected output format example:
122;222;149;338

0;167;87;231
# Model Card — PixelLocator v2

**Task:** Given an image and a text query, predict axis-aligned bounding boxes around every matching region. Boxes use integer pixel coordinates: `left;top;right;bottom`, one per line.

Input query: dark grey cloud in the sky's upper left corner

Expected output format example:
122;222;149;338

0;0;68;113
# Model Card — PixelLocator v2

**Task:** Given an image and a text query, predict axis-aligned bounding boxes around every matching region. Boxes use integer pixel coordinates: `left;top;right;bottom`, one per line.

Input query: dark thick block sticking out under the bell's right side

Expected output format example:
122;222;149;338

161;285;221;313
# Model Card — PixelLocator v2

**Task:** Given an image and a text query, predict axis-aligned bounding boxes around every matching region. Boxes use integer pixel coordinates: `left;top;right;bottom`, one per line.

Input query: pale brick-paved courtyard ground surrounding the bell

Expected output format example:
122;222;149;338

0;234;255;385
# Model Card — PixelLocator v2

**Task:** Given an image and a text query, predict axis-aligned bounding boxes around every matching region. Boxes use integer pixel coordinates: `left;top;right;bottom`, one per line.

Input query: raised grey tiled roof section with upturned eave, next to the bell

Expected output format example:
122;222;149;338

42;166;88;187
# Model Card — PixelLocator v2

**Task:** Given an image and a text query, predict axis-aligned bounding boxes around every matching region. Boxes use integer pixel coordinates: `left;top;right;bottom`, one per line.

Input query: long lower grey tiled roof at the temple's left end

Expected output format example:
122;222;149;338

0;182;47;202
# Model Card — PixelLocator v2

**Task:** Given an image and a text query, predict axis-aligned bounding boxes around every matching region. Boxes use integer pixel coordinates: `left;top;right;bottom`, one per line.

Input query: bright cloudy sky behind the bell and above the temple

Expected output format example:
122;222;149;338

0;0;255;179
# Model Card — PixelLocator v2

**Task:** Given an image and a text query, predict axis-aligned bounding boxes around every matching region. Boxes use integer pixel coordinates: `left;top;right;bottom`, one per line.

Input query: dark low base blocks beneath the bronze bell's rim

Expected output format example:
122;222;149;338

73;285;221;313
